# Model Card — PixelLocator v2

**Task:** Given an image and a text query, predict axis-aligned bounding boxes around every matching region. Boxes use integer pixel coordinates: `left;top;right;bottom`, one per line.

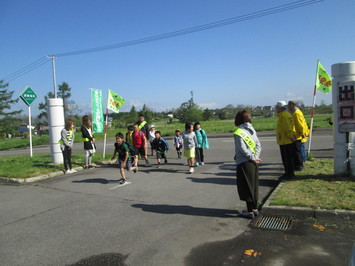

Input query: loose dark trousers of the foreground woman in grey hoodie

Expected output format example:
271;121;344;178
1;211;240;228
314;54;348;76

237;161;259;212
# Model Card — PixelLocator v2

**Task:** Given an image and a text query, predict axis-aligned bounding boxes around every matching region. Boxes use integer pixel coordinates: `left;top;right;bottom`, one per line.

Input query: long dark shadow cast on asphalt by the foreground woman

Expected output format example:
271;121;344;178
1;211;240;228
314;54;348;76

132;204;239;218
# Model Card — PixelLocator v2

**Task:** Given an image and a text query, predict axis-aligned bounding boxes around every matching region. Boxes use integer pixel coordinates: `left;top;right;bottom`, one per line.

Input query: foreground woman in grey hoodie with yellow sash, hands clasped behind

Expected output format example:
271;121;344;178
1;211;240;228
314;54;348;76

234;110;261;219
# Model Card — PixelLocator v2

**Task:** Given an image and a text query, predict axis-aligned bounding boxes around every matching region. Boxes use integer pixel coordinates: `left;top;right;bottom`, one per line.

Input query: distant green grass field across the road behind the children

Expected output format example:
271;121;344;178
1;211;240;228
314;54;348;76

0;114;332;151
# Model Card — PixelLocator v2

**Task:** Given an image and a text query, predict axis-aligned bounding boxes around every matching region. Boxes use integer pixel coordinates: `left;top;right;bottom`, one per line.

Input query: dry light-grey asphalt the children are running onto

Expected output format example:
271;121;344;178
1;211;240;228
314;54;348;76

0;132;344;265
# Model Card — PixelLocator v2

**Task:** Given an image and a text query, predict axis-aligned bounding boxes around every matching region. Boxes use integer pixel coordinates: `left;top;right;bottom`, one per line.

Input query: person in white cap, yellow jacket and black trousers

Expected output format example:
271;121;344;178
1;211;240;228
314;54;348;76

275;101;295;179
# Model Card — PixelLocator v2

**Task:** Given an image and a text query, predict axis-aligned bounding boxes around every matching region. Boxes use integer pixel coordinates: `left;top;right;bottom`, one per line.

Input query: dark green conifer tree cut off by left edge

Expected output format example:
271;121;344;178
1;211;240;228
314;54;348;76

0;80;22;136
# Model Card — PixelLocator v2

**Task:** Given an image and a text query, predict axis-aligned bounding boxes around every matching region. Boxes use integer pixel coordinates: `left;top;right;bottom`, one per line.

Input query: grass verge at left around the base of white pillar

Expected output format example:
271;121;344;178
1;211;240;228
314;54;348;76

0;153;109;178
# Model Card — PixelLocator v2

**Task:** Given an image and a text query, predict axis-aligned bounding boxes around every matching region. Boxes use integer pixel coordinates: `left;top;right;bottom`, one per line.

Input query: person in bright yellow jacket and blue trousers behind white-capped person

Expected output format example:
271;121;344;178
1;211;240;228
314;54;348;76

287;101;309;171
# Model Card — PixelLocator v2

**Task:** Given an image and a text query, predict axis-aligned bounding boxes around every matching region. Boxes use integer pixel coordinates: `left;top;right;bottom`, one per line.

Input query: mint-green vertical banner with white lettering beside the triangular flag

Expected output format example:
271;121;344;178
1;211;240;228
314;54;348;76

91;89;104;133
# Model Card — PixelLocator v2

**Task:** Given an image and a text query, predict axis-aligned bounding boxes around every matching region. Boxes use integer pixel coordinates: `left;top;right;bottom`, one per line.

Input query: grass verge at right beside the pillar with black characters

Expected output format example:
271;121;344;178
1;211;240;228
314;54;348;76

271;159;355;210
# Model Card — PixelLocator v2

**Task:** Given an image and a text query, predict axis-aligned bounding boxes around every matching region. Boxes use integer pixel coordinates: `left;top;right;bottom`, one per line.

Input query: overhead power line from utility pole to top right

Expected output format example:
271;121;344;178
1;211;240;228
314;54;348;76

53;0;324;57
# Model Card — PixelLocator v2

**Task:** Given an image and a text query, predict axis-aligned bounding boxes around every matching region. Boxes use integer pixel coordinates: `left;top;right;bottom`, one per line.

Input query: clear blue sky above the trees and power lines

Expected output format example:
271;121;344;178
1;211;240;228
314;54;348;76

0;0;355;114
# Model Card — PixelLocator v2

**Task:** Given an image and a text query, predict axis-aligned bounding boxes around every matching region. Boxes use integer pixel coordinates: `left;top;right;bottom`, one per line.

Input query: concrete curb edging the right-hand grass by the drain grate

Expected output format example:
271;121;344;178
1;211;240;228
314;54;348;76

262;181;355;220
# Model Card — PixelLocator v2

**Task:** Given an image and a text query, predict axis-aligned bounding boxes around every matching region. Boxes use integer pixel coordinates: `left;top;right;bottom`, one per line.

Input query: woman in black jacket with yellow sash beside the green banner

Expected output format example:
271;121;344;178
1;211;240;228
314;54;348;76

81;115;96;169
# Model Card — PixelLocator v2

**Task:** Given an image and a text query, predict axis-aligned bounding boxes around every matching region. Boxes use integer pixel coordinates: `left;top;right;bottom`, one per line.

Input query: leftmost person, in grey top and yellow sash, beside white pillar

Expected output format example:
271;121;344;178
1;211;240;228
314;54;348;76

59;119;77;174
